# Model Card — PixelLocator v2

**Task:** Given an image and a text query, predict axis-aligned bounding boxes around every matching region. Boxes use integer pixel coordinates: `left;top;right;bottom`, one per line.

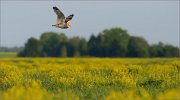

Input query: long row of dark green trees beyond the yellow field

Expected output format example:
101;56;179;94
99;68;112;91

18;28;179;57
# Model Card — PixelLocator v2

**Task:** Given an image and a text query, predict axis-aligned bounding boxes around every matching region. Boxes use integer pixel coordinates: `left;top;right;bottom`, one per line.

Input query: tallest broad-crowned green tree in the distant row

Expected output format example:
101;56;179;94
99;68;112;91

102;28;130;57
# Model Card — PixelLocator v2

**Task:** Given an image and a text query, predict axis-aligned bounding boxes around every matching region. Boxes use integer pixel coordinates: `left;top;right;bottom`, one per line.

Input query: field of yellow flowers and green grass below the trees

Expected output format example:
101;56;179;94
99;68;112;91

0;58;180;100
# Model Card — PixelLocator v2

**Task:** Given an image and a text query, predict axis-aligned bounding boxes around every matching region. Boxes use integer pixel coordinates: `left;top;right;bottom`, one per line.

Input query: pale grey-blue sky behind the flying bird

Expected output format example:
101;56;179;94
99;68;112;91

0;0;180;47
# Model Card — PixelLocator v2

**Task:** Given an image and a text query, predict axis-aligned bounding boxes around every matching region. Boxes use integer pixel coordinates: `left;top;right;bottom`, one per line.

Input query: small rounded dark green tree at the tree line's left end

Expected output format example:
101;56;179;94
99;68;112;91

19;38;41;57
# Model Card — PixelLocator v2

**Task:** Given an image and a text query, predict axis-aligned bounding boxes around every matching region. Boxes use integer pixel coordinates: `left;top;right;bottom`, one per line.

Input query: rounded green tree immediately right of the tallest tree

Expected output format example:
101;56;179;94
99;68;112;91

127;36;149;57
